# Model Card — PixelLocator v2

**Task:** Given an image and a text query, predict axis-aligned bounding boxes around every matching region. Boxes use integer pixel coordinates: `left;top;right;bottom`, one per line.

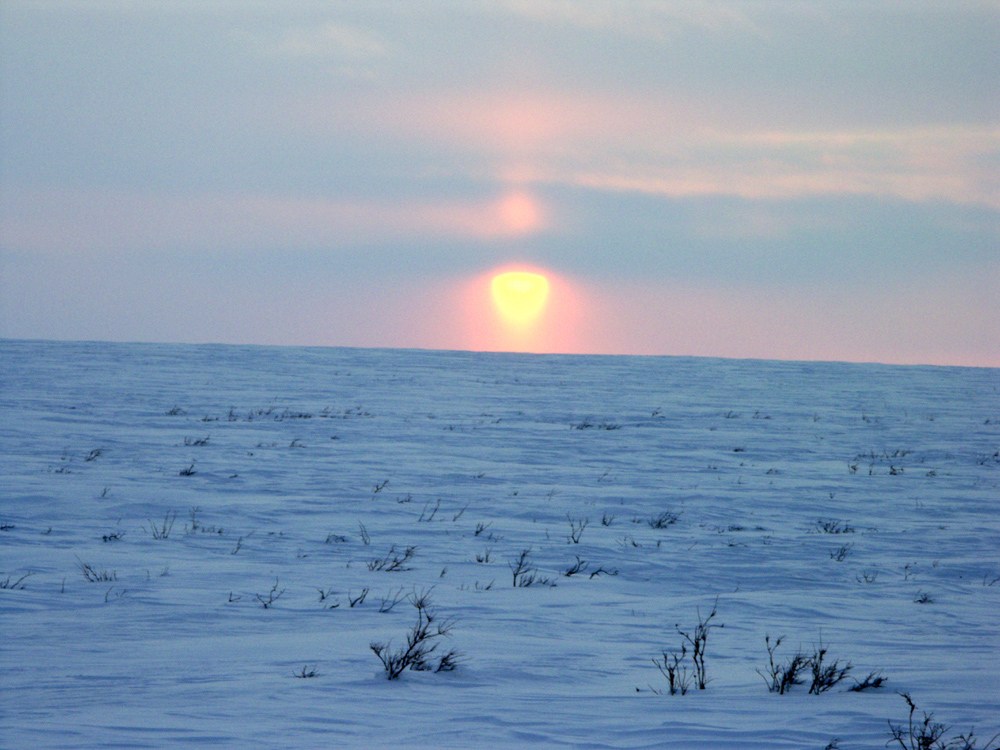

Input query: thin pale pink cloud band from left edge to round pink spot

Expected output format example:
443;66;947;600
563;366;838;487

0;189;553;254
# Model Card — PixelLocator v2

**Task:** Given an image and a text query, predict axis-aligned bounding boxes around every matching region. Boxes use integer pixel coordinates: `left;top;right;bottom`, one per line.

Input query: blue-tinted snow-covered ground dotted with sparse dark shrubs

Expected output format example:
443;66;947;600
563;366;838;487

0;341;1000;750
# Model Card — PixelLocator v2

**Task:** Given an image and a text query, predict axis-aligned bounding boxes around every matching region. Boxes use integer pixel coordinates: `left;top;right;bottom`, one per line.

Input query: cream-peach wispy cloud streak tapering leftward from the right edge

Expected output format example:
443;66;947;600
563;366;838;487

556;126;1000;209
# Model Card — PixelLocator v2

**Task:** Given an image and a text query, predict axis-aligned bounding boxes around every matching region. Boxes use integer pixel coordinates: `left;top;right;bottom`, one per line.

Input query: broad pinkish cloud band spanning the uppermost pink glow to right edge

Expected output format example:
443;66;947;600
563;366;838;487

306;91;1000;208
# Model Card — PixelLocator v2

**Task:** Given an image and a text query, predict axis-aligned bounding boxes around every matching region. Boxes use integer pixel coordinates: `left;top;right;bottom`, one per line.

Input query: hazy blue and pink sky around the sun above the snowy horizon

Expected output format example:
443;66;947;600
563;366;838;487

0;0;1000;367
